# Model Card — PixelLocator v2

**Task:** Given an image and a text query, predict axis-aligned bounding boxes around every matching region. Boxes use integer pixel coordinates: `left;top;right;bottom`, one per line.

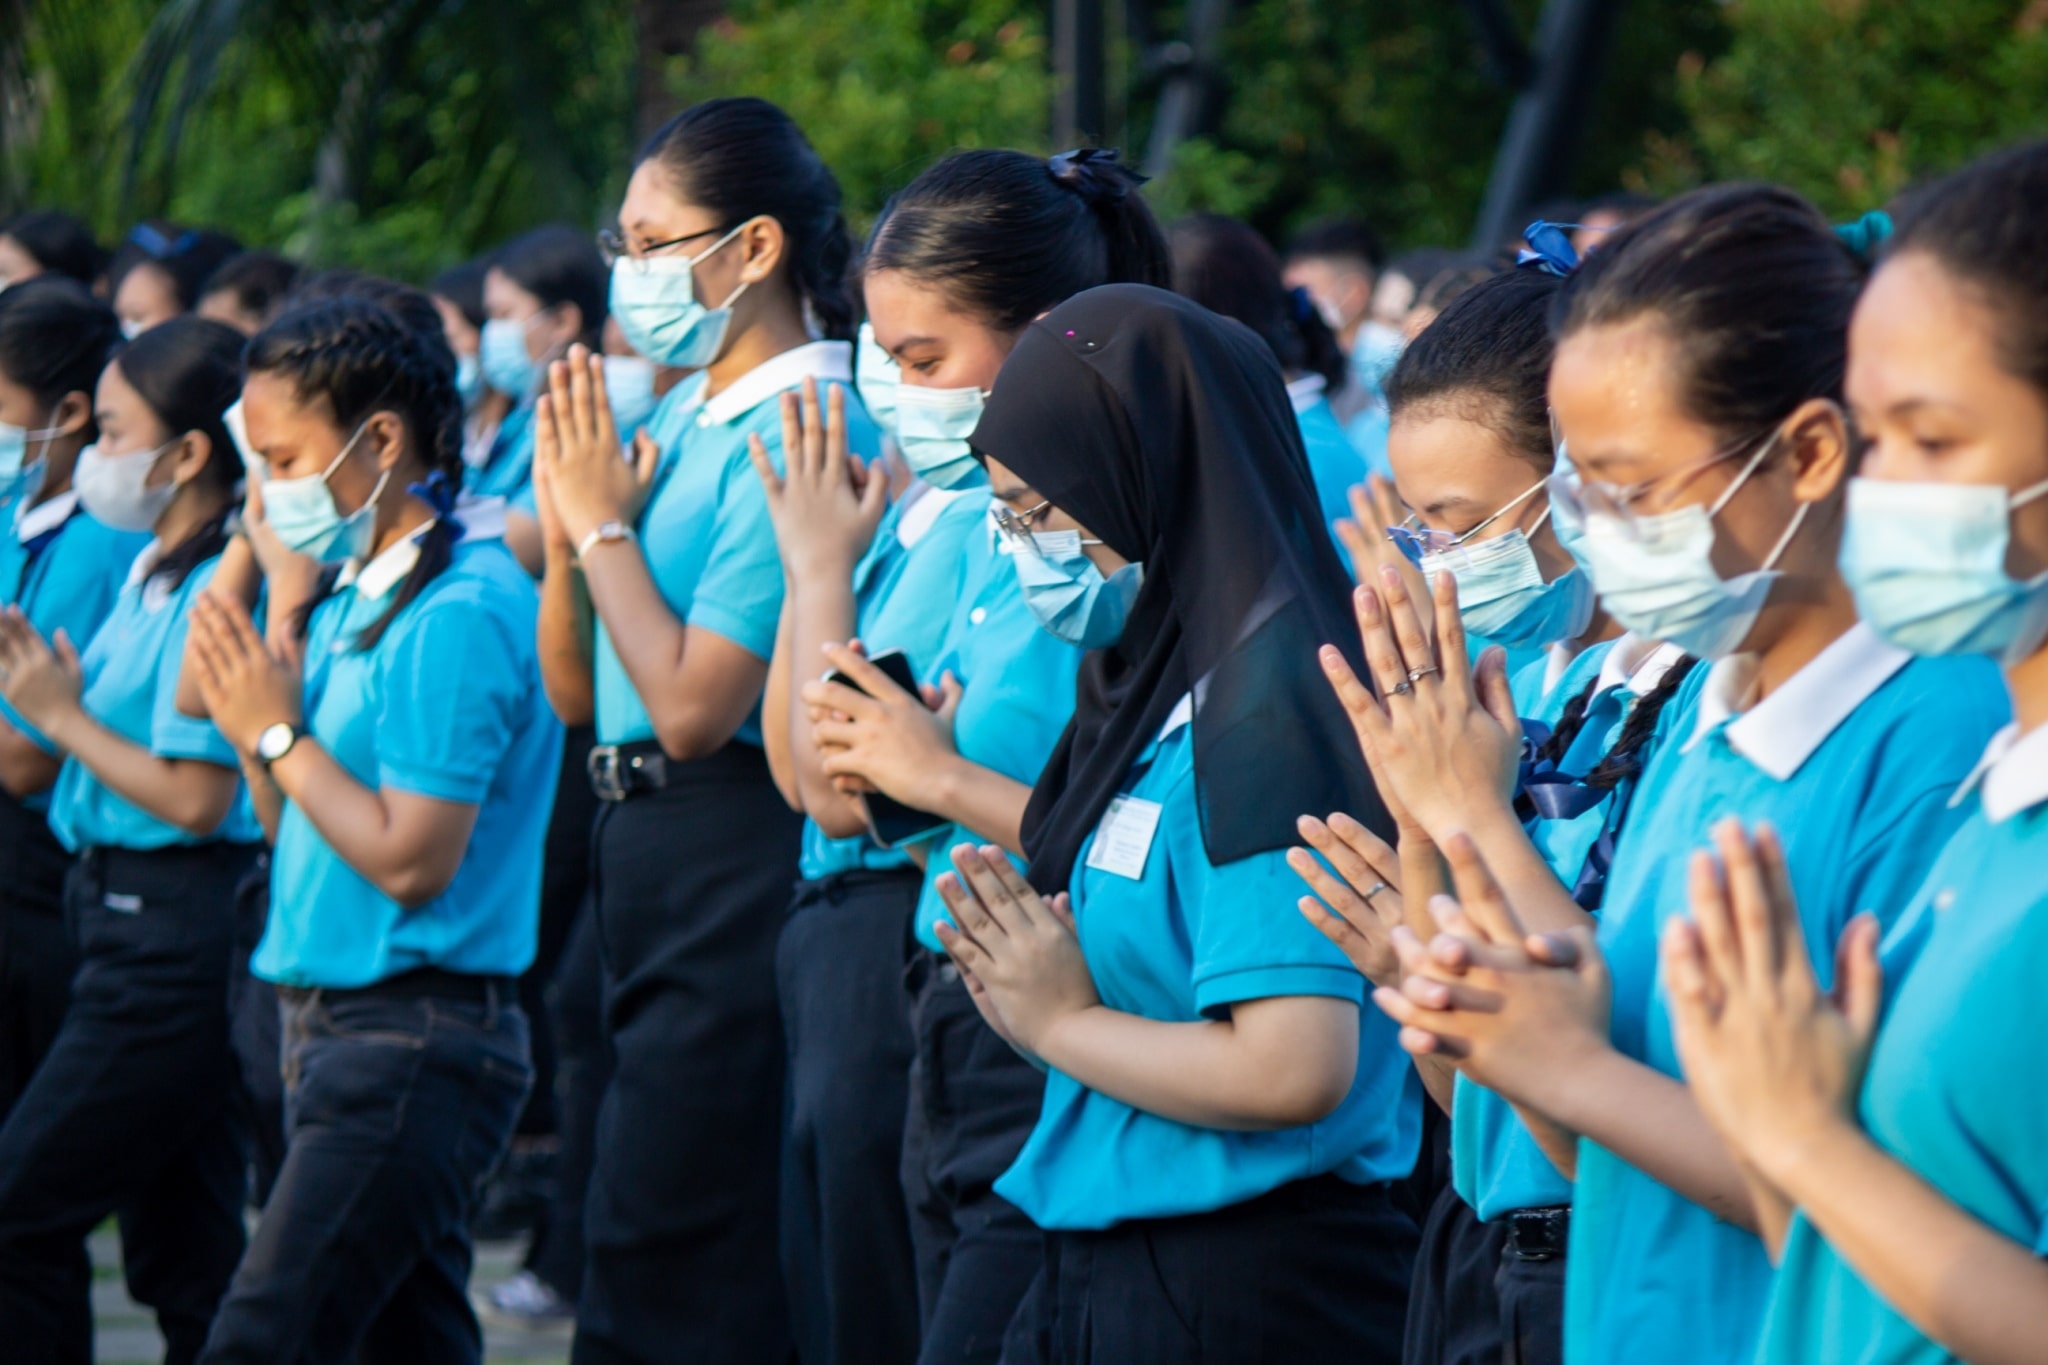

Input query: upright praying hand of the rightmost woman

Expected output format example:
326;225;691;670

1663;821;1884;1181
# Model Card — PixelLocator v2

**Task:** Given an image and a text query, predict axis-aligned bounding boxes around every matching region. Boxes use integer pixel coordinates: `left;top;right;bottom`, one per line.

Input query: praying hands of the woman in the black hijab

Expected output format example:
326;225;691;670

938;845;1102;1056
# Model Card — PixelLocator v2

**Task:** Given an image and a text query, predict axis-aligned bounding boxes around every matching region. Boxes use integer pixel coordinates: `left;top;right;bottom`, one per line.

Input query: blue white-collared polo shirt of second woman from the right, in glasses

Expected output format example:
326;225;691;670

1565;626;2009;1365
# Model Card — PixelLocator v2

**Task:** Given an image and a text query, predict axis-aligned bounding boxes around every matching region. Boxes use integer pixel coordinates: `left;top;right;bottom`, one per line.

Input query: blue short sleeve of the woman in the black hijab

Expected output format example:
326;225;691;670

1167;802;1366;1015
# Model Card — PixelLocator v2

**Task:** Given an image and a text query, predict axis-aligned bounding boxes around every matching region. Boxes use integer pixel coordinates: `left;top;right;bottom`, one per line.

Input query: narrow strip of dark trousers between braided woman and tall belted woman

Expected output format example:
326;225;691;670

526;894;612;1304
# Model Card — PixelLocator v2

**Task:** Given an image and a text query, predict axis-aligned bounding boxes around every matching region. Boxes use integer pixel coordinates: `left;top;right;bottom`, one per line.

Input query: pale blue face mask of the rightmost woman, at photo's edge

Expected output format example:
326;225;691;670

1841;479;2048;665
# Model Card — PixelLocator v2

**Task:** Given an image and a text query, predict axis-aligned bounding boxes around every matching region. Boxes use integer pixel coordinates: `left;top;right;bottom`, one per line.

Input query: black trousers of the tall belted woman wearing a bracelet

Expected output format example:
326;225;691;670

571;743;801;1365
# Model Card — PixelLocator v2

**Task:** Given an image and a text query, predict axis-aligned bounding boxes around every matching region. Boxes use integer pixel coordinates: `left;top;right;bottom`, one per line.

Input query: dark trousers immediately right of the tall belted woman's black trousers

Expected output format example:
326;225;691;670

776;870;924;1365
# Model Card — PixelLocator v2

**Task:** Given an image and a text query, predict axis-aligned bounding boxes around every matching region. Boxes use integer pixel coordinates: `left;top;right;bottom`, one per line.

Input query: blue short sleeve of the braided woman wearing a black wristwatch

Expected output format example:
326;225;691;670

377;593;520;804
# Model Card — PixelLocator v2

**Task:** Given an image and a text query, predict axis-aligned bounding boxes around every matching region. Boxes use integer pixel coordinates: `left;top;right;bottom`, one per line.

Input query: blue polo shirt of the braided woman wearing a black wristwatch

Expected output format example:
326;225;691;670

262;538;577;990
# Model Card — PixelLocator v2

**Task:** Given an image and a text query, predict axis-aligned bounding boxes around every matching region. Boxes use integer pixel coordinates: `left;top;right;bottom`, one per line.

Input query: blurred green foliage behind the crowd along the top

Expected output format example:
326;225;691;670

0;0;2048;278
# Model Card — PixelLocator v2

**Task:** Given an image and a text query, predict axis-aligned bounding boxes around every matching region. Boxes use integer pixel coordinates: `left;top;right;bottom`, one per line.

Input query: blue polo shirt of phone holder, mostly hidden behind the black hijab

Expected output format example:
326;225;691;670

915;522;1085;952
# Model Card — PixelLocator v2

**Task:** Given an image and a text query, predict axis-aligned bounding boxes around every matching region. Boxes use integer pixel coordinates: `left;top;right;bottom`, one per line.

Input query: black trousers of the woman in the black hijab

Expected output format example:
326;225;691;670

1001;1175;1415;1365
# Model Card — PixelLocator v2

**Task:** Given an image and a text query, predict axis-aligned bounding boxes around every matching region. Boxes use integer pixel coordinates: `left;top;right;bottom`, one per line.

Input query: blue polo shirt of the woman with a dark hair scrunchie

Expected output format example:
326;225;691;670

799;483;989;880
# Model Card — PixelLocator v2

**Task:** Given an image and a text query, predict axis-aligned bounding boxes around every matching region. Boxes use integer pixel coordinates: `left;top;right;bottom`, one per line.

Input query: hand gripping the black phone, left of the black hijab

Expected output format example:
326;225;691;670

801;645;961;810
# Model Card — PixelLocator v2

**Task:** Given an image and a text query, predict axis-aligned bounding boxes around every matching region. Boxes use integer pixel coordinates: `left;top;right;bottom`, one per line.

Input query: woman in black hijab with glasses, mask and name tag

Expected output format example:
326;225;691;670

940;284;1419;1365
